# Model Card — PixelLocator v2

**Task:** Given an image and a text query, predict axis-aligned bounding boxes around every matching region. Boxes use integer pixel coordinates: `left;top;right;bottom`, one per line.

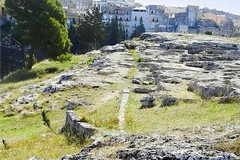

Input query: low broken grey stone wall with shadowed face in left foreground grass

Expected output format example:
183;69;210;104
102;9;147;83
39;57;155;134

64;111;96;138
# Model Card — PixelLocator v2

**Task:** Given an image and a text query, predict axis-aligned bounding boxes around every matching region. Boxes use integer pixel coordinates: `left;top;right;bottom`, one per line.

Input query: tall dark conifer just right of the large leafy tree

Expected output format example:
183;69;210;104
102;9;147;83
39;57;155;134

78;7;105;51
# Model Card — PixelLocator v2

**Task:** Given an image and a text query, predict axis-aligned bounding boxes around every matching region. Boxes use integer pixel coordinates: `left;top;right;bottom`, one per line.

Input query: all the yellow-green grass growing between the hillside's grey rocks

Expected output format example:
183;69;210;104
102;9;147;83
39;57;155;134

0;40;240;159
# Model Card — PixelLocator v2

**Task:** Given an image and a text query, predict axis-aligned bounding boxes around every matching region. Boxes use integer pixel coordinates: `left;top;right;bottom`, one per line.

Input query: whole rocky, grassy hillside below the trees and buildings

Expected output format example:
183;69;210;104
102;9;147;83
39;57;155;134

0;33;240;160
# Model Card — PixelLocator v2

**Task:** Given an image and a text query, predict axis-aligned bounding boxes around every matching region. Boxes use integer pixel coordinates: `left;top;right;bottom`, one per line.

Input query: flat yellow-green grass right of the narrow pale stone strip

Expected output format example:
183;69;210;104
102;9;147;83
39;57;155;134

125;93;240;133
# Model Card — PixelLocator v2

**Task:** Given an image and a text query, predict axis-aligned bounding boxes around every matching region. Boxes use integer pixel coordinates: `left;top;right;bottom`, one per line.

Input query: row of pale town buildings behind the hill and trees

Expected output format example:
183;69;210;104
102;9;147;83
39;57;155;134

63;0;240;37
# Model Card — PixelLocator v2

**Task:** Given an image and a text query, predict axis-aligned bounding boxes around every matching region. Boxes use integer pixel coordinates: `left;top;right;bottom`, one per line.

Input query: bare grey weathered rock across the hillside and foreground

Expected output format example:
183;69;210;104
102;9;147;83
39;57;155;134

0;33;240;160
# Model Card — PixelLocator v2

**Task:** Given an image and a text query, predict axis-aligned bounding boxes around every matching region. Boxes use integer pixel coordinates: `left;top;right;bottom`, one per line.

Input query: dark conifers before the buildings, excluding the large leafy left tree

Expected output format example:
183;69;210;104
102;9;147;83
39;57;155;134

69;8;145;53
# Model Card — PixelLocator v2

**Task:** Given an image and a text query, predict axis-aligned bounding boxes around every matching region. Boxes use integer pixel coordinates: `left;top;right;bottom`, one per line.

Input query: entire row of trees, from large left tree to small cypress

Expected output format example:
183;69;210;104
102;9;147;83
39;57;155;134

5;0;145;69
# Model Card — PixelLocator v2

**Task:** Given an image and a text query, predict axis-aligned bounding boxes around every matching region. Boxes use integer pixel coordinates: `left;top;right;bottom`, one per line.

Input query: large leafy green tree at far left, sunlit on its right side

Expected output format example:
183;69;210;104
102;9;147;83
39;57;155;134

6;0;71;69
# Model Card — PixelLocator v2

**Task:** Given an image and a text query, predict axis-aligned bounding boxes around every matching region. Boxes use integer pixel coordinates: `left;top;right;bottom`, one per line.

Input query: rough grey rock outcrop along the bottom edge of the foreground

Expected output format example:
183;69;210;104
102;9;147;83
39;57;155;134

62;131;240;160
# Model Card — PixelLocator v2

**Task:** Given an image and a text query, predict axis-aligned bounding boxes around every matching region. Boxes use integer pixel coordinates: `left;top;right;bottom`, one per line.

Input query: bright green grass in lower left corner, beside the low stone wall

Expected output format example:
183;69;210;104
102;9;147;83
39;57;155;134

0;111;81;160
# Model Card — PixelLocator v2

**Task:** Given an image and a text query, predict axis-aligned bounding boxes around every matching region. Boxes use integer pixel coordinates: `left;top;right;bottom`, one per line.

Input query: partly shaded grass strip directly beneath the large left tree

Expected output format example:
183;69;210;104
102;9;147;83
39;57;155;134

0;55;87;94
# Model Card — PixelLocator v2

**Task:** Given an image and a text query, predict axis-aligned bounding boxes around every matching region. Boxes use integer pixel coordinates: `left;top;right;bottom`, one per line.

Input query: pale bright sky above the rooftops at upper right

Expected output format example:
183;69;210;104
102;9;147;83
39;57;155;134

135;0;240;15
